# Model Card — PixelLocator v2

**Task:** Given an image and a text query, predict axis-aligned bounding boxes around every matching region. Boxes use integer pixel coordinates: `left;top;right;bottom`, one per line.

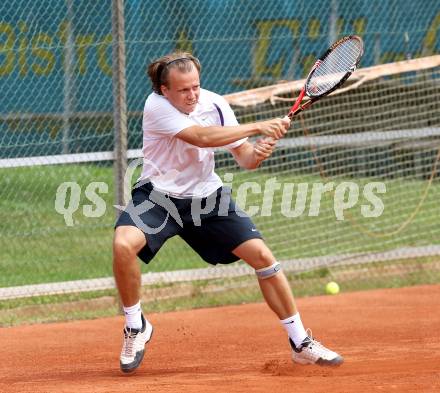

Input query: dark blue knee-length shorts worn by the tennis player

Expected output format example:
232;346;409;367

115;183;262;265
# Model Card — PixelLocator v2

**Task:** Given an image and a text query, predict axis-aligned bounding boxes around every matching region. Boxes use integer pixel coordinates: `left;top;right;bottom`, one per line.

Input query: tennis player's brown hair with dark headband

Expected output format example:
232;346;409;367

148;52;201;95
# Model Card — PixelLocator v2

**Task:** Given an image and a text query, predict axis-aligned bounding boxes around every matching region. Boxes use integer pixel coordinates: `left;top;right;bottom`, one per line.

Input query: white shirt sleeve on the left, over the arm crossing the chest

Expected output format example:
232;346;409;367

142;93;196;136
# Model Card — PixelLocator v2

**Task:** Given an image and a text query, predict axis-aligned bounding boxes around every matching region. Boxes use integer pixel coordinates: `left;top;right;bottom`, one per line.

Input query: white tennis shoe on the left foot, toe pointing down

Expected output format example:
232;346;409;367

119;315;153;373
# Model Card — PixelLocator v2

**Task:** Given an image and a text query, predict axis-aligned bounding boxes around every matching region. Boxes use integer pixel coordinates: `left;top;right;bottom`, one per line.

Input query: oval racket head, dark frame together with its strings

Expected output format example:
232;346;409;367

304;35;364;99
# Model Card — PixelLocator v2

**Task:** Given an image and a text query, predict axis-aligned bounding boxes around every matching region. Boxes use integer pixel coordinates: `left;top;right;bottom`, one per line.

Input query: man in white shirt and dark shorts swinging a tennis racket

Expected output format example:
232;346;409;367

113;52;343;373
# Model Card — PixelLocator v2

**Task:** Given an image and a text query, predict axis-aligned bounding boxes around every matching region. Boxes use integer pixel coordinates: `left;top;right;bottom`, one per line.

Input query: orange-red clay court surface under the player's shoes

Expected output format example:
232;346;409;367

0;285;440;393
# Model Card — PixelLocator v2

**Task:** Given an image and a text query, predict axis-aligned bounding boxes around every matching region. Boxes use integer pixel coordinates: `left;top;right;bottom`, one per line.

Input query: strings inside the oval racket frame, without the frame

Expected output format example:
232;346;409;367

307;39;362;96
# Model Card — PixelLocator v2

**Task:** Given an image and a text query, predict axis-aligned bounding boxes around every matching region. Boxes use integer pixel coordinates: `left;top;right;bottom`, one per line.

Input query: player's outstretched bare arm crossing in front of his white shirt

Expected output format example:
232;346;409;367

176;119;290;147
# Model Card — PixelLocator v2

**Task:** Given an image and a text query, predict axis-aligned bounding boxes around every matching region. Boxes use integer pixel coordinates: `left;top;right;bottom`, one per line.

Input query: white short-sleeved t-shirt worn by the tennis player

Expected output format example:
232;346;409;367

139;89;247;198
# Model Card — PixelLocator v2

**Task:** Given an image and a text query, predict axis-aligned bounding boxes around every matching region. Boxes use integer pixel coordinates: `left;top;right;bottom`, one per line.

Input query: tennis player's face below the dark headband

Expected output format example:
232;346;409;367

161;67;200;113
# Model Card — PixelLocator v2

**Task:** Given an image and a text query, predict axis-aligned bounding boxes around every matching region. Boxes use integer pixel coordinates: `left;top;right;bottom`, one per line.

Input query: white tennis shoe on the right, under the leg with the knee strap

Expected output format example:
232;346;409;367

289;330;344;366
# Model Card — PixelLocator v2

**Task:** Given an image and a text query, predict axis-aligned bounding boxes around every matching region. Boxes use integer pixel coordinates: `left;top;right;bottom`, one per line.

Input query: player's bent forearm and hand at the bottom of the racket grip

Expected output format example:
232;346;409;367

231;138;276;169
